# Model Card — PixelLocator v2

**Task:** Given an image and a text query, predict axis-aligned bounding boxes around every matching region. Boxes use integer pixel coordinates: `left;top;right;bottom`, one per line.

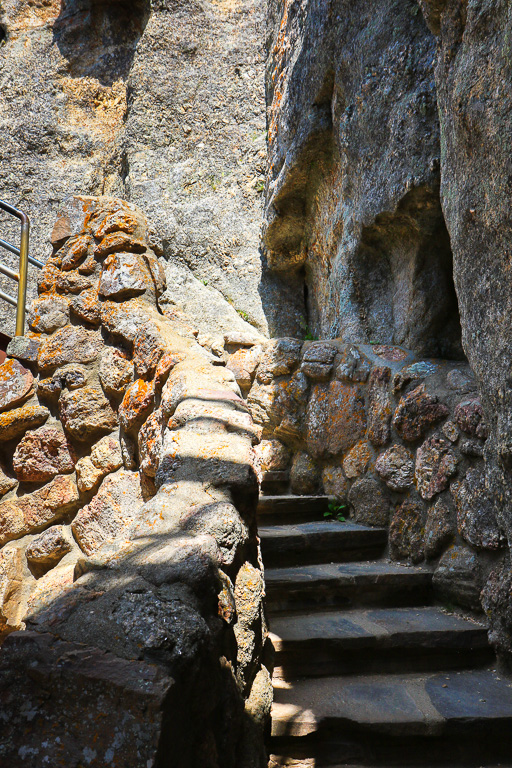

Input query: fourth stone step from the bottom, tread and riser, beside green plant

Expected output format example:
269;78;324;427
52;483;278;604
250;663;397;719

259;520;387;567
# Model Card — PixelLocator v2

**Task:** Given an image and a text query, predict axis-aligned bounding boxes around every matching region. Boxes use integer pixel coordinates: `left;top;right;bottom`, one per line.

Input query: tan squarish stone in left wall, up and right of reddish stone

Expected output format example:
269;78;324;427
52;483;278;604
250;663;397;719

59;387;117;442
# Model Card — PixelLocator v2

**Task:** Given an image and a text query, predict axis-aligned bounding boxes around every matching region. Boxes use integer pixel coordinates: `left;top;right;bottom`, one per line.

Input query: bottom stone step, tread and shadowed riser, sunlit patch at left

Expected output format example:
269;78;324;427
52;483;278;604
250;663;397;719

271;669;512;768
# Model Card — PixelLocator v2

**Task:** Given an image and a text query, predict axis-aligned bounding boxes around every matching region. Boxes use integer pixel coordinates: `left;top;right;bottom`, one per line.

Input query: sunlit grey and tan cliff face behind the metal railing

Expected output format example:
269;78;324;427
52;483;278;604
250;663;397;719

0;0;303;337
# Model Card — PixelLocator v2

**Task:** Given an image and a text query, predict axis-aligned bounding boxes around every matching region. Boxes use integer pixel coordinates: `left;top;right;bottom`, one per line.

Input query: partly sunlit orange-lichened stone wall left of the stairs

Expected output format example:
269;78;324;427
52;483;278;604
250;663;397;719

0;198;271;768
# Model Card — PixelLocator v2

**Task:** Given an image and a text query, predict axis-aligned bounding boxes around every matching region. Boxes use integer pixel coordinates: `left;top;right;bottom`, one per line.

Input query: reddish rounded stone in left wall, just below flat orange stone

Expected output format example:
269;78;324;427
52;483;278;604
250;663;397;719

13;427;76;483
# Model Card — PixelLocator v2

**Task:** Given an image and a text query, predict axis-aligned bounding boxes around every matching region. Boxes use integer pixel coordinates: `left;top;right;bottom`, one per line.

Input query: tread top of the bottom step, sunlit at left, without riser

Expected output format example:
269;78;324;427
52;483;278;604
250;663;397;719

272;670;512;746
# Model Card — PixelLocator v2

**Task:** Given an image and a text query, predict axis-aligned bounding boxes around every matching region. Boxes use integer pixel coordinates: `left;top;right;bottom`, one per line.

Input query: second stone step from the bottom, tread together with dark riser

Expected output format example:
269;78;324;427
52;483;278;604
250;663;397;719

270;606;494;680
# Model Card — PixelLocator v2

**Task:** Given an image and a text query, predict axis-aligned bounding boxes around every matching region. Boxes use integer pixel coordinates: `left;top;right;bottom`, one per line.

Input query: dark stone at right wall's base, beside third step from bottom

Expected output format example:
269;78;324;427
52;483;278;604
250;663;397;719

433;547;483;611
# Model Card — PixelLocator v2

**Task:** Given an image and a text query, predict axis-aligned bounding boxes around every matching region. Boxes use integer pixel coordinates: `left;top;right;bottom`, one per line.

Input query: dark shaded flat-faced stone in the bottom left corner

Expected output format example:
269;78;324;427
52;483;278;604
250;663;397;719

0;632;175;768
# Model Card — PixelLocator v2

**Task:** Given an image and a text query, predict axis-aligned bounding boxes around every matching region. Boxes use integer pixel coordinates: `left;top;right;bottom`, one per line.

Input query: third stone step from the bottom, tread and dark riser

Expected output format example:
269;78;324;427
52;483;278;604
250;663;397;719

265;560;432;613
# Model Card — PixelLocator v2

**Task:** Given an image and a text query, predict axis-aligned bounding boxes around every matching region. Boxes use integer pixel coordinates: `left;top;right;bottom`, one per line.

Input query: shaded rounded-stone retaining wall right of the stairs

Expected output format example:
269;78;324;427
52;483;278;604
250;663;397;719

232;338;508;650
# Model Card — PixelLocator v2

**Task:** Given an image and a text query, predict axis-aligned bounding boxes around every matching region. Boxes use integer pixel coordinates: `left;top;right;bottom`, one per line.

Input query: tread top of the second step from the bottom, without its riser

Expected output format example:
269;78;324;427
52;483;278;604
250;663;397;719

271;606;488;651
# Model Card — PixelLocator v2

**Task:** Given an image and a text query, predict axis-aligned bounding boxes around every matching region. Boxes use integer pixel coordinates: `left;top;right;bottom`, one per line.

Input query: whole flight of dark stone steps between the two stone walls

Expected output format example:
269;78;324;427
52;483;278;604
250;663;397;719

259;496;512;768
